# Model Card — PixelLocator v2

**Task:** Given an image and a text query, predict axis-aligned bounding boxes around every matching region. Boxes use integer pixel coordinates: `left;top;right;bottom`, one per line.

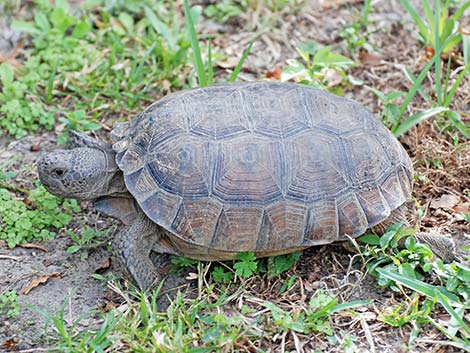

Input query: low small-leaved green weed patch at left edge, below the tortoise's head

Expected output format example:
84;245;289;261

0;186;80;248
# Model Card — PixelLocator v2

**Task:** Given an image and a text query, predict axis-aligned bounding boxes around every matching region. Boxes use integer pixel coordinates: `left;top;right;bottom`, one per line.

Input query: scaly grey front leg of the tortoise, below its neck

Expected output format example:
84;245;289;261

113;212;162;290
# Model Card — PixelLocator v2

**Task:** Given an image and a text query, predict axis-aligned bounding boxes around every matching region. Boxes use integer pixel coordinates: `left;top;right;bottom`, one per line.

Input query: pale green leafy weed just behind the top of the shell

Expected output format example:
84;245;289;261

282;41;354;95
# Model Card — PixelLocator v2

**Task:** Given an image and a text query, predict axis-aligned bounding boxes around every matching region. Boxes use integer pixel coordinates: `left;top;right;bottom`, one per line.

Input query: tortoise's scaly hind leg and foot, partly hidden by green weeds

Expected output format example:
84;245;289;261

372;204;457;263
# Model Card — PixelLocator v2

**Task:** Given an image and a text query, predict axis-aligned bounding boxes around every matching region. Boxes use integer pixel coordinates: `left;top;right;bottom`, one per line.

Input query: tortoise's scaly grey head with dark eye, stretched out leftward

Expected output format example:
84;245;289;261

38;132;125;200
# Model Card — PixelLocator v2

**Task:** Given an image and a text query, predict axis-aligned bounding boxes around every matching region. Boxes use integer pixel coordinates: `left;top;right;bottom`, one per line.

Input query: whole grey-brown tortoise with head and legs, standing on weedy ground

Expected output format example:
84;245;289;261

38;82;453;289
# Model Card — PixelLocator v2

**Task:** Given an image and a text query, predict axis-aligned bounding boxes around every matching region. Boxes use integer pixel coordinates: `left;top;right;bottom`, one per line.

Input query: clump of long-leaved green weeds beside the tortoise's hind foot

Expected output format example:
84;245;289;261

359;225;470;349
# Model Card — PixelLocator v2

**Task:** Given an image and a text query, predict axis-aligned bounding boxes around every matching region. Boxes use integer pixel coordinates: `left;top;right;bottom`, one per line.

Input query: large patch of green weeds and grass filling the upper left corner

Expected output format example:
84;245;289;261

4;0;200;142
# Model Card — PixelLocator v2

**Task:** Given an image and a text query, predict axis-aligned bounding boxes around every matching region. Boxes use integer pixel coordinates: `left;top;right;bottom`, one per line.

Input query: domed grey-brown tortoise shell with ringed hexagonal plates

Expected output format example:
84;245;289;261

112;82;413;253
